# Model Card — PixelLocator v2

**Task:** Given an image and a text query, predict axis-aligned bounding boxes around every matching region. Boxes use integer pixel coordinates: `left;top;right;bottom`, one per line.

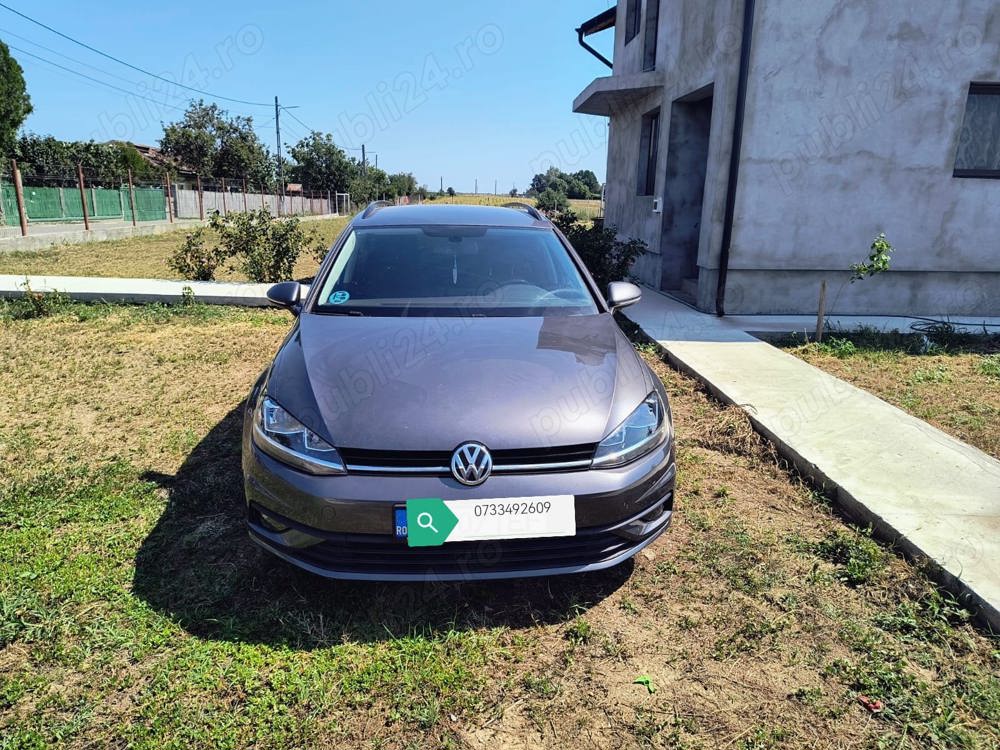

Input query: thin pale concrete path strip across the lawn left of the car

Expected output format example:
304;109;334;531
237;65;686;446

0;275;271;307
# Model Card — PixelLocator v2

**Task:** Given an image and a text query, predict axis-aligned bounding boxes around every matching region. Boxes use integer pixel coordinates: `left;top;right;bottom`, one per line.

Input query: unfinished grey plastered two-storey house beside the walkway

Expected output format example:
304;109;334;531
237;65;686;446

573;0;1000;316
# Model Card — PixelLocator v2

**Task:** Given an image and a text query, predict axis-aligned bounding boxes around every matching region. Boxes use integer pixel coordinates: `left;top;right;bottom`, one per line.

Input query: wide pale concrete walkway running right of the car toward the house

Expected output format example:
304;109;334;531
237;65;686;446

625;289;1000;631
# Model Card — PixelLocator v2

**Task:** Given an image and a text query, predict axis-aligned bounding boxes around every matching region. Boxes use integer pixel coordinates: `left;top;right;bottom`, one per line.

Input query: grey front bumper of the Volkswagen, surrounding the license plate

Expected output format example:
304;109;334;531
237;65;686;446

243;434;675;581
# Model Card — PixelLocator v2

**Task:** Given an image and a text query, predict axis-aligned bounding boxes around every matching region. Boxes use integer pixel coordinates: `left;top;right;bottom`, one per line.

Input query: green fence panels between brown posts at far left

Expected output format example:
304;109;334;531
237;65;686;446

0;184;167;226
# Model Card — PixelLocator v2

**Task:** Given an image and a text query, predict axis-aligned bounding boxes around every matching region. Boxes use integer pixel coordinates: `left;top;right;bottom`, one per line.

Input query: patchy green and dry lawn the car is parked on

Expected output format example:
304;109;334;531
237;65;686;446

0;303;1000;750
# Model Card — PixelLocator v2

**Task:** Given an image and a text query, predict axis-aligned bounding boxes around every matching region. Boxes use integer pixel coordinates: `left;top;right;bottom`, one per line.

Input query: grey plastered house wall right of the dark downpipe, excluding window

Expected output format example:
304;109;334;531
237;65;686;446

727;0;1000;315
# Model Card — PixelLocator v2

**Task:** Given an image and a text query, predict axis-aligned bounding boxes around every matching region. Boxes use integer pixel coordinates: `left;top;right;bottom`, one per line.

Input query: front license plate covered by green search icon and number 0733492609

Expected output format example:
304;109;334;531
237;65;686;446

406;495;576;547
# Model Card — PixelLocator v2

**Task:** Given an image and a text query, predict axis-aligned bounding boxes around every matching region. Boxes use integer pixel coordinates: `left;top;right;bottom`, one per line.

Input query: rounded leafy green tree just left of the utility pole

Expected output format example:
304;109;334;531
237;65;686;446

160;100;274;186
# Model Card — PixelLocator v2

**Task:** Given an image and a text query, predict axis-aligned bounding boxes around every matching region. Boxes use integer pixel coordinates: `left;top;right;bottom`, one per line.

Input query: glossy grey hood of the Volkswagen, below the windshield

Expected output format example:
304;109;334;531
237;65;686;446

268;314;652;451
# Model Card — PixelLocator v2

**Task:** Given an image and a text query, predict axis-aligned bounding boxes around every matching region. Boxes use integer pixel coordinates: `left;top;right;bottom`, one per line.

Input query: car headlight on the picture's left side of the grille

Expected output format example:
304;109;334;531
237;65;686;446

253;396;346;474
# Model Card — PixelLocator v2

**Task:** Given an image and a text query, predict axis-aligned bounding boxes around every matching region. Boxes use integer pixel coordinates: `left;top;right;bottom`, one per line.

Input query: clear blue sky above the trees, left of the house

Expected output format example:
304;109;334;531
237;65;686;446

0;0;612;192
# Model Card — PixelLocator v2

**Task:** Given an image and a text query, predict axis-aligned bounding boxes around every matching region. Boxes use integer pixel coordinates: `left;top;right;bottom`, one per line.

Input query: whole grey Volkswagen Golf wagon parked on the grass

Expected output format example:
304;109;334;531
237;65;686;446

243;204;675;580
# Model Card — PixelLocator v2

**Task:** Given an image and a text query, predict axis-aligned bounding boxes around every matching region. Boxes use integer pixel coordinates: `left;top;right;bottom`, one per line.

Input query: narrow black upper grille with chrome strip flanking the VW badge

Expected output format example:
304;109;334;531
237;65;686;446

337;443;596;474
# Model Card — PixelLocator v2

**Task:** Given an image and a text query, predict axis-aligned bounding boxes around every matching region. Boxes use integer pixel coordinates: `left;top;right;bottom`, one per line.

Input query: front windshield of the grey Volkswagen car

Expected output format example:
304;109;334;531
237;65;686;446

315;226;598;316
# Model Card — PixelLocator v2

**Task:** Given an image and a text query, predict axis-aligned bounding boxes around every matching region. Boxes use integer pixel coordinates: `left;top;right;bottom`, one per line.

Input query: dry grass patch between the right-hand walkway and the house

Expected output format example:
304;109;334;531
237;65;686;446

787;332;1000;458
